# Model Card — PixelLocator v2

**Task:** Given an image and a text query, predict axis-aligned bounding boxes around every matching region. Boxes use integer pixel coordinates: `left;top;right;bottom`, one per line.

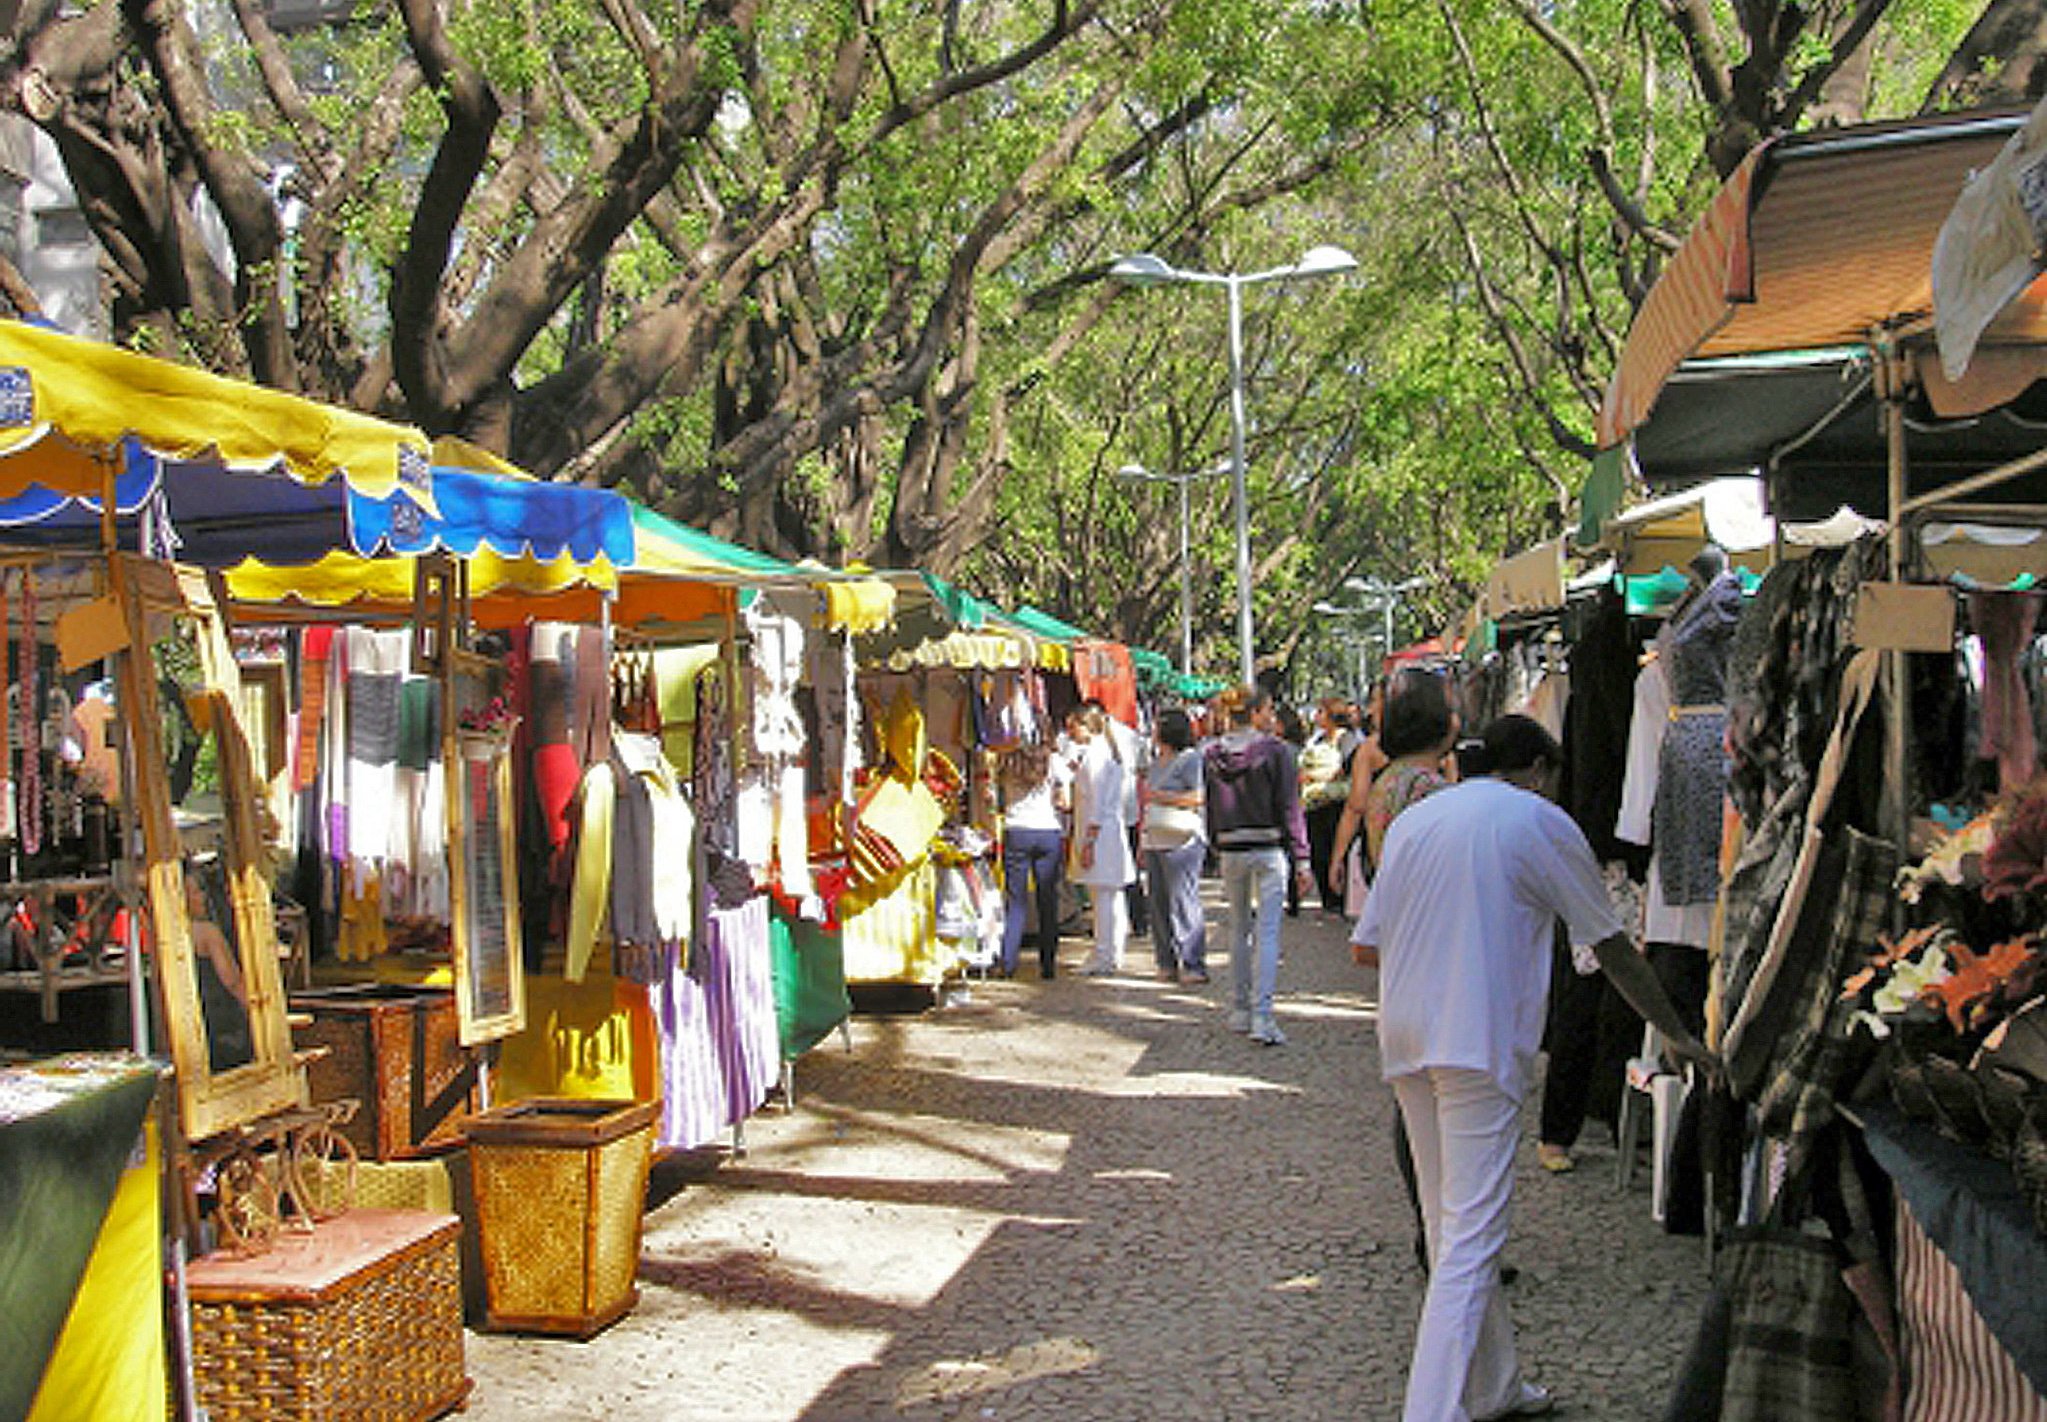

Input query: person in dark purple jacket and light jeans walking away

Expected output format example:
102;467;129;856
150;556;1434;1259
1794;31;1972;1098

1202;685;1310;1048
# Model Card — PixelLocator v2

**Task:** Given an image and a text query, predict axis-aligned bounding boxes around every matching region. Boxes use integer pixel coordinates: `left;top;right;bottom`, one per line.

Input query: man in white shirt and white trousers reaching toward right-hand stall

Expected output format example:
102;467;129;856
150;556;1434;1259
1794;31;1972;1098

1351;716;1711;1422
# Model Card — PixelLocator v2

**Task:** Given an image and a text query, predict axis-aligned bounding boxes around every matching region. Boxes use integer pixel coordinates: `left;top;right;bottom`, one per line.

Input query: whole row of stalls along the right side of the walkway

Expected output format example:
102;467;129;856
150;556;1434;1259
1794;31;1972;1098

1445;110;2047;1418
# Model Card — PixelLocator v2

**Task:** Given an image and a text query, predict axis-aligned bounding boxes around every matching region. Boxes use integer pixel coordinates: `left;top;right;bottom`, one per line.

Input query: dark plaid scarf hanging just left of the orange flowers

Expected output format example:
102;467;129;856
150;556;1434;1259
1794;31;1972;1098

1756;829;1898;1170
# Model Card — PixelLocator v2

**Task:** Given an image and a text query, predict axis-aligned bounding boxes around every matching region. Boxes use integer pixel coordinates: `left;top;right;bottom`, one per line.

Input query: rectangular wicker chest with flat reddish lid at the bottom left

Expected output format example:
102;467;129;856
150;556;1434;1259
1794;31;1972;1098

186;1209;469;1422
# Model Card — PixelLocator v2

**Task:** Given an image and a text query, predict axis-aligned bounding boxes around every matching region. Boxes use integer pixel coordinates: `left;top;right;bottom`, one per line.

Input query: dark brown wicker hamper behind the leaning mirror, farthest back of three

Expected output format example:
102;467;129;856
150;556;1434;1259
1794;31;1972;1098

291;982;477;1160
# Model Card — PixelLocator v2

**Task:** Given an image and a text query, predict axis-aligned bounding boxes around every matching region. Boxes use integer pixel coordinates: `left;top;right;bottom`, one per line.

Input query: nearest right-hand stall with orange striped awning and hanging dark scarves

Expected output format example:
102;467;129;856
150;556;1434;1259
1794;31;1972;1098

1584;102;2047;1416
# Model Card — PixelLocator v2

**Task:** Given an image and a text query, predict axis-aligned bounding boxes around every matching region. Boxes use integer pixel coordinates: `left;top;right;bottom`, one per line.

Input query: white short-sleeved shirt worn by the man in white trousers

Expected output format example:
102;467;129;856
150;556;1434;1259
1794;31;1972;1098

1351;775;1621;1101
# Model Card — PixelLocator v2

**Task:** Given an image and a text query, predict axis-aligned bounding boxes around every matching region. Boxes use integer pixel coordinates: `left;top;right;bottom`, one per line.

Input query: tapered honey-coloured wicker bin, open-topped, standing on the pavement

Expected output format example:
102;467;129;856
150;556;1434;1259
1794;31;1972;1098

469;1097;655;1338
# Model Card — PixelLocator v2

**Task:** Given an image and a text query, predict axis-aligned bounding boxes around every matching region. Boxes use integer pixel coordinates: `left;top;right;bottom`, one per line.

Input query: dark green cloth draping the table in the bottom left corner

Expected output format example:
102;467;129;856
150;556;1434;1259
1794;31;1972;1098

0;1062;156;1418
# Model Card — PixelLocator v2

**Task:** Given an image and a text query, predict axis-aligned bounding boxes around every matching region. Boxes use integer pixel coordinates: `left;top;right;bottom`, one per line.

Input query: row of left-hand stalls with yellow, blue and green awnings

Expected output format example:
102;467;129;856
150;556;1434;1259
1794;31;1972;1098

0;321;1191;1418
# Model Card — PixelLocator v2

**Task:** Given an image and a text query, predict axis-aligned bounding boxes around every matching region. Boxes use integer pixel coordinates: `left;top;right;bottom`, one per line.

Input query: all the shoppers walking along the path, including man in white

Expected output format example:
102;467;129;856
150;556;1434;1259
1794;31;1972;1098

999;671;1717;1422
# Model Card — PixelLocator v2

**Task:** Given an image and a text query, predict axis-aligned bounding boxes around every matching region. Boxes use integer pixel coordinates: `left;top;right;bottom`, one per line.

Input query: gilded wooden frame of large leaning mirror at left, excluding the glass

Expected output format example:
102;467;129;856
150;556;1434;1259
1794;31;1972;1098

113;554;307;1142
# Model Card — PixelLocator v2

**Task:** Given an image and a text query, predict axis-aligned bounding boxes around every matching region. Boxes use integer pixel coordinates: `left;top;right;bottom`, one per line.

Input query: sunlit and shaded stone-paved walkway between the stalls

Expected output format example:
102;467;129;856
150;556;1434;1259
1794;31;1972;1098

467;884;1705;1422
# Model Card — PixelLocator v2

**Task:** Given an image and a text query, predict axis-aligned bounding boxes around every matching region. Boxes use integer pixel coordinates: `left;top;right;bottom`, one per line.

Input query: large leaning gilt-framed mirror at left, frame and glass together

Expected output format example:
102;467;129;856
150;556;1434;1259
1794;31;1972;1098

115;554;305;1142
